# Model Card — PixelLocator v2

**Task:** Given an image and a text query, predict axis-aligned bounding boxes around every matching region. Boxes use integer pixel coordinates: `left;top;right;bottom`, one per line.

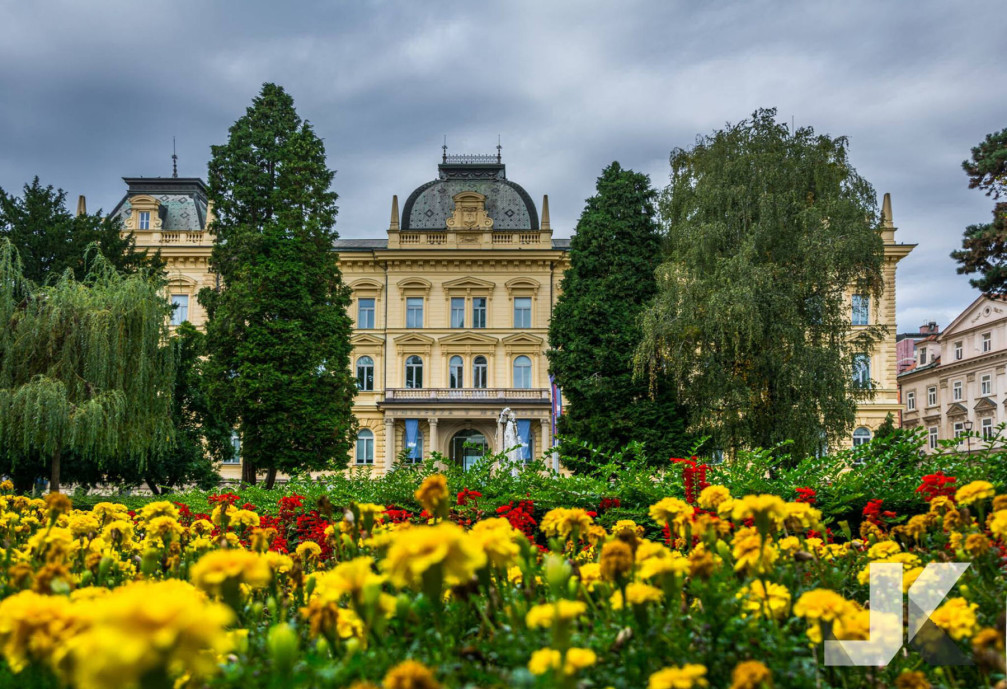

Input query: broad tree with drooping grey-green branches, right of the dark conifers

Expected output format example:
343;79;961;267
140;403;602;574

637;110;884;456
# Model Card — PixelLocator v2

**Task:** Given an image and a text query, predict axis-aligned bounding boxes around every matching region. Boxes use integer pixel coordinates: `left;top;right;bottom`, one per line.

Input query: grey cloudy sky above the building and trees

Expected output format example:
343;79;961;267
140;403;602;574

0;0;1007;330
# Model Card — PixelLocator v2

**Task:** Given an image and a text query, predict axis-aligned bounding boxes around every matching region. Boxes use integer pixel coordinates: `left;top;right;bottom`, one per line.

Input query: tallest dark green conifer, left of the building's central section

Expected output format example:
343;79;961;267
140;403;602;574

199;84;355;486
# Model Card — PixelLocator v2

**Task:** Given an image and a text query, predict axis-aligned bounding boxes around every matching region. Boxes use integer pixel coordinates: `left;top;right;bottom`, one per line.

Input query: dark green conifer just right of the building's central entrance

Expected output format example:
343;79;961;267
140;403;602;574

548;162;689;468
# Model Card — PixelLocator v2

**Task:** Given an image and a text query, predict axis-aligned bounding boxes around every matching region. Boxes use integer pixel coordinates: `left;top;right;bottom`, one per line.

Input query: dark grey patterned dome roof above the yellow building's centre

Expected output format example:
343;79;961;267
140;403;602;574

402;155;539;231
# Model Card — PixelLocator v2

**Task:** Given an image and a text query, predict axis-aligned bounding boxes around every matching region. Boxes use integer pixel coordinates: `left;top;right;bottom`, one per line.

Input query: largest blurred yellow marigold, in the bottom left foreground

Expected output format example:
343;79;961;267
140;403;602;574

66;579;234;689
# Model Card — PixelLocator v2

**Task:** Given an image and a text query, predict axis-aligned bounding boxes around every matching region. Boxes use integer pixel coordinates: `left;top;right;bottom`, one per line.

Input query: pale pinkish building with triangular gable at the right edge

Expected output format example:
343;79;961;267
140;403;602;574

898;296;1007;453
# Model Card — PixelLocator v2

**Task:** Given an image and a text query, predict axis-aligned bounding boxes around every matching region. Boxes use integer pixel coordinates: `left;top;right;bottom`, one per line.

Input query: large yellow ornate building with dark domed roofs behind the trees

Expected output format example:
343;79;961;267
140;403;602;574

112;154;912;478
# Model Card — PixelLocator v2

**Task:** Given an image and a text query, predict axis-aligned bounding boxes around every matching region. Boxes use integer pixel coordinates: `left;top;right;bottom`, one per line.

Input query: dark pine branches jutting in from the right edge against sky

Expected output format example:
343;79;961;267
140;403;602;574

951;129;1007;297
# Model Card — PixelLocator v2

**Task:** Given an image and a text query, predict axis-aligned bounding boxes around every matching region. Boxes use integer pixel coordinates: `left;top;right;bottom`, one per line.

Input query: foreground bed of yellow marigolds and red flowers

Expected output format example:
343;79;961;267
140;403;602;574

0;473;1007;689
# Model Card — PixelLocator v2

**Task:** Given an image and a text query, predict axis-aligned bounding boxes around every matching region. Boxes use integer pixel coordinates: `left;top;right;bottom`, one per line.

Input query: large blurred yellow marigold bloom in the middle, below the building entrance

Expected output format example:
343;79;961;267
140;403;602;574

382;522;486;587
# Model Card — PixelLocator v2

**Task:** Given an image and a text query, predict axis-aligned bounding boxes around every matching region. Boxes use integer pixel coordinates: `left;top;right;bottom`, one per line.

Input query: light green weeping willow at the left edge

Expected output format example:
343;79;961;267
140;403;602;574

0;239;173;491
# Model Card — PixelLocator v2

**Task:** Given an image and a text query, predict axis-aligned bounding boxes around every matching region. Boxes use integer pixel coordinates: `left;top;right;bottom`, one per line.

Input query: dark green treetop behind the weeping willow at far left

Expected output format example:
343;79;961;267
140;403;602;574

0;177;164;284
